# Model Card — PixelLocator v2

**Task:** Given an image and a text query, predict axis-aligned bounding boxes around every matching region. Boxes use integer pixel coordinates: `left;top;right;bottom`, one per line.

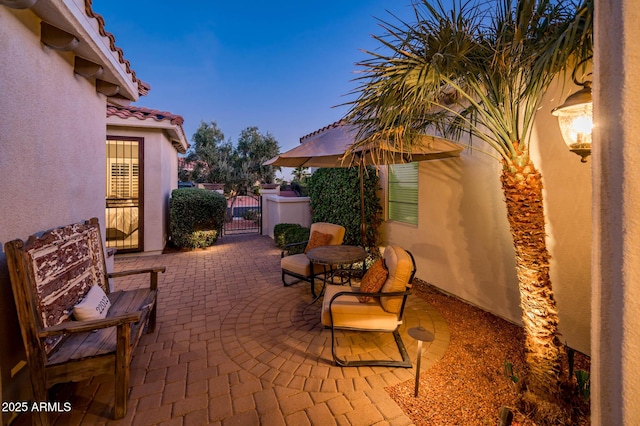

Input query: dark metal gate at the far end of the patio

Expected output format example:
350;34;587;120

224;195;262;235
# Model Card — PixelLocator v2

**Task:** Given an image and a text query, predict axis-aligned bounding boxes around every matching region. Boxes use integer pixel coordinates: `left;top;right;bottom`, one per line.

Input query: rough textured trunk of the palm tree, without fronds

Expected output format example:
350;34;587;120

501;156;562;406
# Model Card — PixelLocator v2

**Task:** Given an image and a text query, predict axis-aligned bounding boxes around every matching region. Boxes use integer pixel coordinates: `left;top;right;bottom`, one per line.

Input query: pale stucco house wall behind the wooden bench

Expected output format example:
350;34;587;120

0;6;106;420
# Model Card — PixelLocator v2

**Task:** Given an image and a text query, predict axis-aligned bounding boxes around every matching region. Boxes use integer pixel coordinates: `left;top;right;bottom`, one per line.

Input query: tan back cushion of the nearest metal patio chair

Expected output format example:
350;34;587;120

380;246;413;314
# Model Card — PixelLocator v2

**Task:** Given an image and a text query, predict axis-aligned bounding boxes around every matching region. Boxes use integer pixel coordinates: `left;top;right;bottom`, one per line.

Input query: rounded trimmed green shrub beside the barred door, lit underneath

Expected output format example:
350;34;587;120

169;188;227;248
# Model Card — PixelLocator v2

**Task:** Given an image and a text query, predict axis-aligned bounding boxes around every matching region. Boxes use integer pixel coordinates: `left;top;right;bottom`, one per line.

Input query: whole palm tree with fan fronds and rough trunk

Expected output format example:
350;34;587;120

347;0;593;422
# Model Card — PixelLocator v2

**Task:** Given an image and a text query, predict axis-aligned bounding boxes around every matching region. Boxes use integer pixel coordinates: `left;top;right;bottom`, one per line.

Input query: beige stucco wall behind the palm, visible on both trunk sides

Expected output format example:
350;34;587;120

381;82;591;354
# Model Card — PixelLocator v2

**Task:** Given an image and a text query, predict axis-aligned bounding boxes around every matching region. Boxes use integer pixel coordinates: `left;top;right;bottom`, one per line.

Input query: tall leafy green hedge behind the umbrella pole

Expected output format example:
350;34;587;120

309;167;382;249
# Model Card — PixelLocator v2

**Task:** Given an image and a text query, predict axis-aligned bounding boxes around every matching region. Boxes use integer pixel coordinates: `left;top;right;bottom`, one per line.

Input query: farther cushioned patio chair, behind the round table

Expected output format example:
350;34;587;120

280;222;346;290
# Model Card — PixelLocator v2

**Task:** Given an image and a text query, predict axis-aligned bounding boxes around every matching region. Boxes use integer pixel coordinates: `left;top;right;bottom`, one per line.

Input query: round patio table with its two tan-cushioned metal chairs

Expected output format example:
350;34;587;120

280;222;416;368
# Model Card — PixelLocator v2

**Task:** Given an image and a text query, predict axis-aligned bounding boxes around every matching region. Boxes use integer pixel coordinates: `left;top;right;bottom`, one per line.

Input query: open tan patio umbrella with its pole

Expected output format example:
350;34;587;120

264;121;462;247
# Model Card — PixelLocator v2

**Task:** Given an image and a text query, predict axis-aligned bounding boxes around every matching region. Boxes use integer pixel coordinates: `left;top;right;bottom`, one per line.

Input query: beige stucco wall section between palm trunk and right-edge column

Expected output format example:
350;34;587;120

531;83;593;354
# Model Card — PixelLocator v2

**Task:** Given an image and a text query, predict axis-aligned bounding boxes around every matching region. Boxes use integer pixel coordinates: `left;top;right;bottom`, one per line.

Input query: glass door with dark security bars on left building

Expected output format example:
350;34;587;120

106;137;144;252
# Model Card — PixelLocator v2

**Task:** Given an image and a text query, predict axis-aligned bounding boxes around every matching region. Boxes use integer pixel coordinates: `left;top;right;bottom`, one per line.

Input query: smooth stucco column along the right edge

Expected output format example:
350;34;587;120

591;0;640;425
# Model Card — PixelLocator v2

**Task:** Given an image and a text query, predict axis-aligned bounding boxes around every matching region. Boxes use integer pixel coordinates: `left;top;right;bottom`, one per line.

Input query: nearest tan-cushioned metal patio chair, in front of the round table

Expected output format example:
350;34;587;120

321;245;416;368
